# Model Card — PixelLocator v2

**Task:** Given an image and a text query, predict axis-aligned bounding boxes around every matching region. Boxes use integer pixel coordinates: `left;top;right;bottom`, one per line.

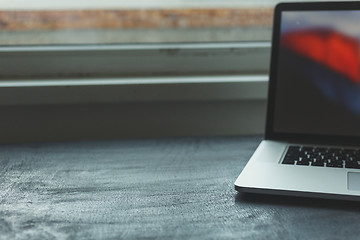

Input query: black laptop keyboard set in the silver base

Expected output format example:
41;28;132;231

282;145;360;169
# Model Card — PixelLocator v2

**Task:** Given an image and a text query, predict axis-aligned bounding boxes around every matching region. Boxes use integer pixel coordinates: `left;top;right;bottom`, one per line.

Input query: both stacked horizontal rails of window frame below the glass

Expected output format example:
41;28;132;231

0;42;270;105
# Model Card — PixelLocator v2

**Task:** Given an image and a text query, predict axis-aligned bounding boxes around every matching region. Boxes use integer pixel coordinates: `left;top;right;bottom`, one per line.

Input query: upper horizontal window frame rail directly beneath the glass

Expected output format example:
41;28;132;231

0;42;270;79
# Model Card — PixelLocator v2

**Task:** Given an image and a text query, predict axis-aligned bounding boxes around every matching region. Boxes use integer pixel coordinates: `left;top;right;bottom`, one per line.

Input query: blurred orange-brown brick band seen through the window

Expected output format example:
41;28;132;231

0;8;273;31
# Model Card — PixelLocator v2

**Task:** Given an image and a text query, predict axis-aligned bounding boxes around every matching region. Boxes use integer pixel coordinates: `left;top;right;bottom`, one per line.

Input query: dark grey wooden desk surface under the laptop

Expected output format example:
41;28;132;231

0;137;360;239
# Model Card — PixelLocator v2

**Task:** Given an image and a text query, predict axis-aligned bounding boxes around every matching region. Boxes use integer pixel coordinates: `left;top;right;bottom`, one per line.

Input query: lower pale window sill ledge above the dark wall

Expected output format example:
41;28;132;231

0;75;268;106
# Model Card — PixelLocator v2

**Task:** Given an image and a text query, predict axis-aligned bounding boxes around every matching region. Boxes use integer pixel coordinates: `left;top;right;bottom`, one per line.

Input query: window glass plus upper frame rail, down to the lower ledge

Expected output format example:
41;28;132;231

0;0;276;80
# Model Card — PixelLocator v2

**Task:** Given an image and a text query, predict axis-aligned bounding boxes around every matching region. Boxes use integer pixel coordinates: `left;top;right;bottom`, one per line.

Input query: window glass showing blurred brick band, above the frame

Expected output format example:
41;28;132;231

0;0;316;45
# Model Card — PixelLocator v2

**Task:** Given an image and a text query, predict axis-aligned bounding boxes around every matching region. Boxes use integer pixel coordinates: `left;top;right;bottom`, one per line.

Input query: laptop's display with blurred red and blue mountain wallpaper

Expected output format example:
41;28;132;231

272;10;360;139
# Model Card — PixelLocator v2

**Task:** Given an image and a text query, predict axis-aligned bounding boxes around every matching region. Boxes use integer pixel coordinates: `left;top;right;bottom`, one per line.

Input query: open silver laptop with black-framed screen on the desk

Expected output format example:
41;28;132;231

235;2;360;200
